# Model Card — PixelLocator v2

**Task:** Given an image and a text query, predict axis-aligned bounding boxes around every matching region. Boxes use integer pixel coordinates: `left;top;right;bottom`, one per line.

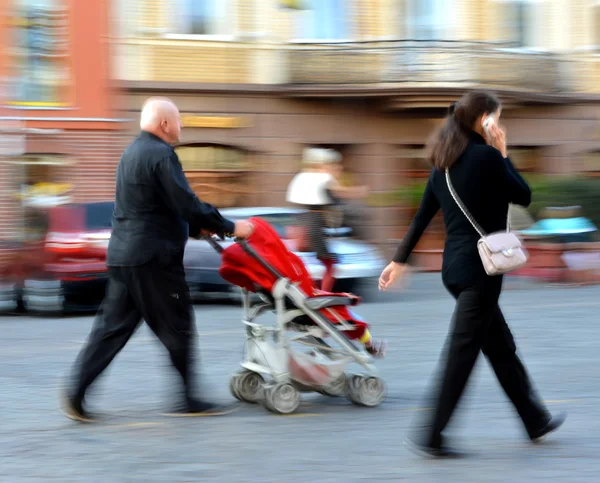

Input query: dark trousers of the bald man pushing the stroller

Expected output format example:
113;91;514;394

71;254;196;400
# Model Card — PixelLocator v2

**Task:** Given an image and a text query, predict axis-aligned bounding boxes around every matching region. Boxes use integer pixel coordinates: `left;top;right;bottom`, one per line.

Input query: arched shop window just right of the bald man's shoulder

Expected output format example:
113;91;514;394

176;145;252;208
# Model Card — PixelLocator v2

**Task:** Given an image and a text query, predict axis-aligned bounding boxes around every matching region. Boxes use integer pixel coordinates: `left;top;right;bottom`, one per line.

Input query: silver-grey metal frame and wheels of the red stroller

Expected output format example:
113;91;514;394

209;238;385;414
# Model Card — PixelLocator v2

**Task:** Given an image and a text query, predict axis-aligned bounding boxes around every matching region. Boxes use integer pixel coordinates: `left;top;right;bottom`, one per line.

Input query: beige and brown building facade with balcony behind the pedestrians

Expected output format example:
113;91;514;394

114;0;600;258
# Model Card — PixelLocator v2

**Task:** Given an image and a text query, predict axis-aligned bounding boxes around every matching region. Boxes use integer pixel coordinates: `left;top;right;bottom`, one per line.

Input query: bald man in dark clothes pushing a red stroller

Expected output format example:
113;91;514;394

62;98;252;421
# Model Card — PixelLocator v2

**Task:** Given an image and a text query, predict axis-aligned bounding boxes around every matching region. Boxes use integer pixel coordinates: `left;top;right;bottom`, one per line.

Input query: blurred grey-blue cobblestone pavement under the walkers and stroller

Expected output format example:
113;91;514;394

0;276;600;483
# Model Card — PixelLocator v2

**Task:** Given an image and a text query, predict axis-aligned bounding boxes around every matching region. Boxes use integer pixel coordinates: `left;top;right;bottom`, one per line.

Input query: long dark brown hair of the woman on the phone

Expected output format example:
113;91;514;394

428;91;500;171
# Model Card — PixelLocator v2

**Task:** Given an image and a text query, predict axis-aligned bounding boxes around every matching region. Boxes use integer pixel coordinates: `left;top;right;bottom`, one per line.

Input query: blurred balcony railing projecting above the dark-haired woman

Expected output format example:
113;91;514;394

288;41;573;93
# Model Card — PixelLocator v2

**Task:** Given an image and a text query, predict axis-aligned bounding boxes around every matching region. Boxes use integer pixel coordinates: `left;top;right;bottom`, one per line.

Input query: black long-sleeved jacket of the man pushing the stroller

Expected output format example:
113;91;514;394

107;131;234;266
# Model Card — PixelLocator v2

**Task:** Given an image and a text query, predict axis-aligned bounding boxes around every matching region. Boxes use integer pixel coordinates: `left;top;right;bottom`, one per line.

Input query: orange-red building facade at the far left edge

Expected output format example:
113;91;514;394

0;0;127;241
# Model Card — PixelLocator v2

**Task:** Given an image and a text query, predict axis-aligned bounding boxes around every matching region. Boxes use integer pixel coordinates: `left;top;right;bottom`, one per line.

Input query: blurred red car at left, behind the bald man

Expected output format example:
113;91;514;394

0;202;114;313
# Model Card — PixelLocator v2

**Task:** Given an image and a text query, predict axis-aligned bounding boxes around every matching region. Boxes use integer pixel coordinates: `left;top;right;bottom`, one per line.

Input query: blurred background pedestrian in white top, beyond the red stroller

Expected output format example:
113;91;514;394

287;148;366;292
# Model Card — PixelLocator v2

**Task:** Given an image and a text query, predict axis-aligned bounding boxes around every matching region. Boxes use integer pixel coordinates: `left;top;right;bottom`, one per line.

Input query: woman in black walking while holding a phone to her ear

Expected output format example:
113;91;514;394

379;91;566;456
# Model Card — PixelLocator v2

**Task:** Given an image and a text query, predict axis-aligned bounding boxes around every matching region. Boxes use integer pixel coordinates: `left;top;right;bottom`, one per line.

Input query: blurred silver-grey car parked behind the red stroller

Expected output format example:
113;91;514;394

184;207;386;296
